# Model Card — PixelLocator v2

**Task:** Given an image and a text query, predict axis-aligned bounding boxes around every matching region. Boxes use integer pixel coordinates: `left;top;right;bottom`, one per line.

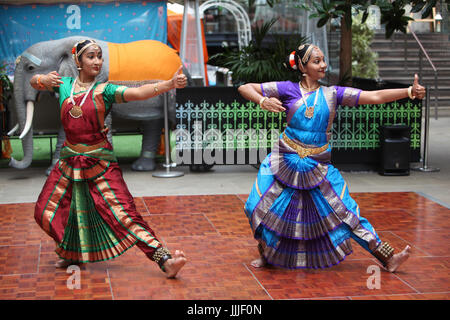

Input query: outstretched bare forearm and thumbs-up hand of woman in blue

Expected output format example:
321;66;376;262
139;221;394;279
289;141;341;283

358;74;425;104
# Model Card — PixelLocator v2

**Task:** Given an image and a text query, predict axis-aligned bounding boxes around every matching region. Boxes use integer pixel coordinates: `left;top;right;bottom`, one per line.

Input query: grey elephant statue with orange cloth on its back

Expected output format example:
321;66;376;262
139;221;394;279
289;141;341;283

9;36;192;173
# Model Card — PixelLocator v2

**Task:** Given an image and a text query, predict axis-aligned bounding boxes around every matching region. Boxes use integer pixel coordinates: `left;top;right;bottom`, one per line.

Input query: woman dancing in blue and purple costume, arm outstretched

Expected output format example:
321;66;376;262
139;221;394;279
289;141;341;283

239;44;425;272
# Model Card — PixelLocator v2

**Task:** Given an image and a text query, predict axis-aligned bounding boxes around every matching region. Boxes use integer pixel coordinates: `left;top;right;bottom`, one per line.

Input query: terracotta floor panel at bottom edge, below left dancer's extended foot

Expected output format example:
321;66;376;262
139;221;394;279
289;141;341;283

109;263;269;300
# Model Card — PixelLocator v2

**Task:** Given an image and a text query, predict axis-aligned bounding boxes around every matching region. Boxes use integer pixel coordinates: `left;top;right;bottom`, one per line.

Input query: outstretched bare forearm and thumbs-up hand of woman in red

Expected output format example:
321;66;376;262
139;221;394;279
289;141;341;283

124;66;187;101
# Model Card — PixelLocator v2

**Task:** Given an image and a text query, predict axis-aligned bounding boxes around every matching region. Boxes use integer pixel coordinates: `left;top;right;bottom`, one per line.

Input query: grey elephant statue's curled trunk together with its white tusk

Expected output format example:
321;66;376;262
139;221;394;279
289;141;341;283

9;63;36;169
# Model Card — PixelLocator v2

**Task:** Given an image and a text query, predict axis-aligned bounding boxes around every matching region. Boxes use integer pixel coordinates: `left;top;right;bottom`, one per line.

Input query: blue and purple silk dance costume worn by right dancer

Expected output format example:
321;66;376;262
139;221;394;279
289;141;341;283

245;81;381;269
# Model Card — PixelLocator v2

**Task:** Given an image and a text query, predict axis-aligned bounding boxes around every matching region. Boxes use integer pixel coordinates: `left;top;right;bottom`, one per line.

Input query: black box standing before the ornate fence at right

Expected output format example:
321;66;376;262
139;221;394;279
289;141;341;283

380;124;411;176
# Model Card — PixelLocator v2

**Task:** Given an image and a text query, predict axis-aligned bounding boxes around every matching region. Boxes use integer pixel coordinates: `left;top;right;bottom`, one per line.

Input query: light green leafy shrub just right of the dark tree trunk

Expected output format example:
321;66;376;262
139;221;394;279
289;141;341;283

352;14;378;79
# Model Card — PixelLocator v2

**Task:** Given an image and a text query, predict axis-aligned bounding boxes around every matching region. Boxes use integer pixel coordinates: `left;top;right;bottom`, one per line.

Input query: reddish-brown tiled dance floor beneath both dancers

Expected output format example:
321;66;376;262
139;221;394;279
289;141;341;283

0;192;450;300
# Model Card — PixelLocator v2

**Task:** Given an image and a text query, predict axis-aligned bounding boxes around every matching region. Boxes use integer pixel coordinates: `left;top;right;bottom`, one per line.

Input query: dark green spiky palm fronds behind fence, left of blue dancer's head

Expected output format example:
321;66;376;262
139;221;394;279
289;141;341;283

208;19;306;86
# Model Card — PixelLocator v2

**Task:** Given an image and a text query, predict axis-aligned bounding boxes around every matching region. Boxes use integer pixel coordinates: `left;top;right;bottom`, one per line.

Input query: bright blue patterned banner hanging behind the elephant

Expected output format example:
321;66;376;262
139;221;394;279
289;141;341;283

0;1;167;75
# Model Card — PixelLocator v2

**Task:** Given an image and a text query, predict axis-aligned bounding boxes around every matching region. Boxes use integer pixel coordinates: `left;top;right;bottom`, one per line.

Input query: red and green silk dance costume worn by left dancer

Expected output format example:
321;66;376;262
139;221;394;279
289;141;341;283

34;77;161;263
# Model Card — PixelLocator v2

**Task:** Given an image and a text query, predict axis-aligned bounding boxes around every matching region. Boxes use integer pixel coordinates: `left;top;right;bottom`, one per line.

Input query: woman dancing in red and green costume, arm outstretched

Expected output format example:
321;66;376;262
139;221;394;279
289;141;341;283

30;40;187;278
